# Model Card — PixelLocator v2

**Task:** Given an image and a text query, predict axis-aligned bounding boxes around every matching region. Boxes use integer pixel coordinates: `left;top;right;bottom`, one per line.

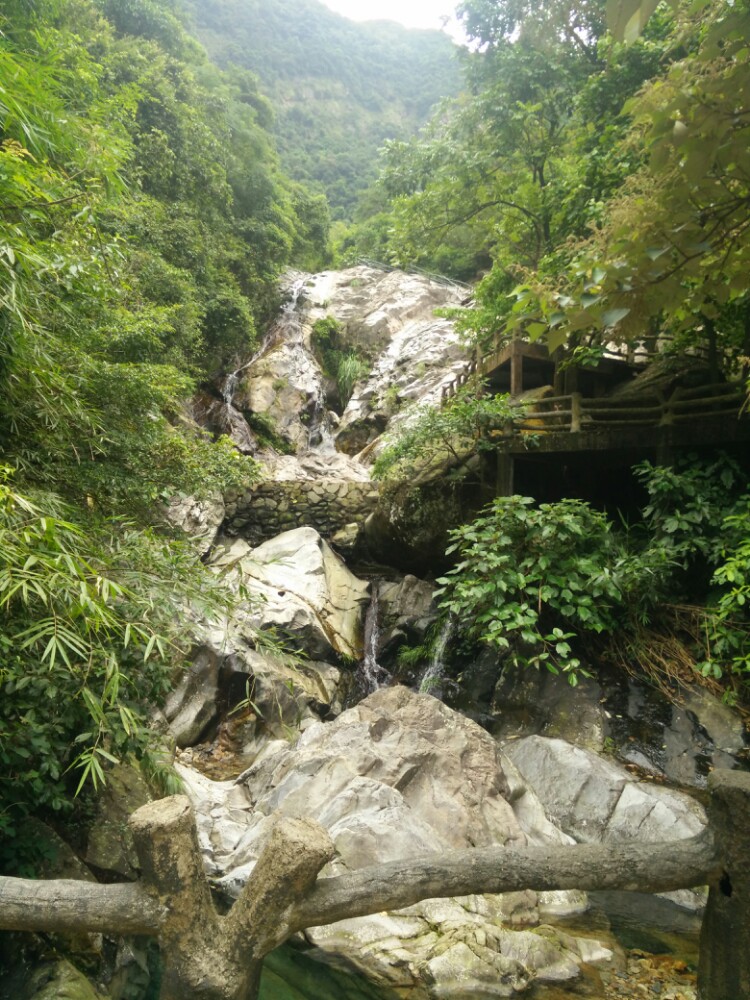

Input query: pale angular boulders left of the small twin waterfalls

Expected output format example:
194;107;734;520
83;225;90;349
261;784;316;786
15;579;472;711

164;527;369;752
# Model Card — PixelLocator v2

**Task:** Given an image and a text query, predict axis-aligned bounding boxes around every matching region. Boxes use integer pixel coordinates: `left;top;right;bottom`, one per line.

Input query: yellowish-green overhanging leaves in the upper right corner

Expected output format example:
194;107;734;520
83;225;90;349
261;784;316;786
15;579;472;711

508;3;750;360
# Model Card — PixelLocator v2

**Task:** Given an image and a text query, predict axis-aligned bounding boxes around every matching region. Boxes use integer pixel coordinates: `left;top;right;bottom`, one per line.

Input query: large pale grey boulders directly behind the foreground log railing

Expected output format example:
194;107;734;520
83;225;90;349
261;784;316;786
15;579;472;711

178;687;712;1000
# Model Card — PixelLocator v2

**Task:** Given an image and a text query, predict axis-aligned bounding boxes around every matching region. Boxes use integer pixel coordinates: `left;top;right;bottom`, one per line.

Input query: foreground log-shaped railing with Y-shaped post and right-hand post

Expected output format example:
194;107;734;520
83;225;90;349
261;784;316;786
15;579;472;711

0;771;750;1000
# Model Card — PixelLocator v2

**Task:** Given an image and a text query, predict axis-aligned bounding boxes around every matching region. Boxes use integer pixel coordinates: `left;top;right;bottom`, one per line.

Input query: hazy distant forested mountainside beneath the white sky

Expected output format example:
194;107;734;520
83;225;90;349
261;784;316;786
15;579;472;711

182;0;461;218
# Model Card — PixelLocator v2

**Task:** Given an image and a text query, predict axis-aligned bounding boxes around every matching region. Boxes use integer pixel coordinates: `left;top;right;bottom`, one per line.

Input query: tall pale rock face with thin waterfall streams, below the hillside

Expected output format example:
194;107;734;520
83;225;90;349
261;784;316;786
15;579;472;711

194;267;466;468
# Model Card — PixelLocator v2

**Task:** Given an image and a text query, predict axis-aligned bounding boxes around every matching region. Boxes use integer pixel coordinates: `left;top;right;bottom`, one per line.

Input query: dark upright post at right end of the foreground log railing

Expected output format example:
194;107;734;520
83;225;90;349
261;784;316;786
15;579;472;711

698;771;750;1000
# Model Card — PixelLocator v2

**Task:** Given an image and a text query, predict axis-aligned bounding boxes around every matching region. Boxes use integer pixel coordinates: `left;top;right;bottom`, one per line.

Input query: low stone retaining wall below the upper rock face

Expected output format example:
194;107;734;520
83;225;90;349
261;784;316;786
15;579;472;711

224;479;378;545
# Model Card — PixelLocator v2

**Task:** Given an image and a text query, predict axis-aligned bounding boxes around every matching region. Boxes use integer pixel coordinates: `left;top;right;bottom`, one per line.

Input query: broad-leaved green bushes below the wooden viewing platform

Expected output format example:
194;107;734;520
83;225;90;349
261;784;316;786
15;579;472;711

437;456;750;700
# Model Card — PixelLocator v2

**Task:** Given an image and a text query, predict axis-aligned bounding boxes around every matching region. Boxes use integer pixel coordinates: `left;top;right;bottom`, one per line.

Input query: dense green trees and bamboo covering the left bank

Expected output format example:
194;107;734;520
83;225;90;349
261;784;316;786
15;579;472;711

0;0;327;860
